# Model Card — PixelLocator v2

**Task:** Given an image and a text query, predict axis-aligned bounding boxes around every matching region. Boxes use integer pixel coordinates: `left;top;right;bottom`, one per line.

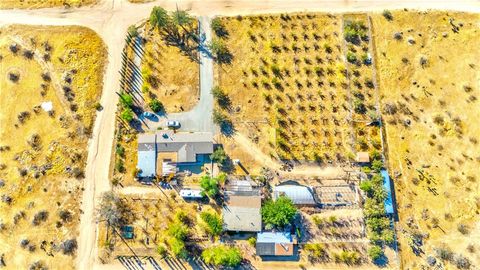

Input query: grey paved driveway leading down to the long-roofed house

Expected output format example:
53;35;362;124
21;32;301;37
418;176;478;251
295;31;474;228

143;16;215;132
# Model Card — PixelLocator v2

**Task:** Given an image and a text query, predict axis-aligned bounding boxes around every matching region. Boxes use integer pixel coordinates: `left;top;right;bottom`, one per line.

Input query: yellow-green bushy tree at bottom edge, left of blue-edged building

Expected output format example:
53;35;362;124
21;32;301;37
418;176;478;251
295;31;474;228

202;245;242;267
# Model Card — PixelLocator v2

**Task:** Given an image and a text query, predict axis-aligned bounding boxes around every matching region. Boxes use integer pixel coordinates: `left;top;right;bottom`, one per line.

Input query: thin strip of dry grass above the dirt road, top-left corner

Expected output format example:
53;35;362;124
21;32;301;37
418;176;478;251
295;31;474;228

0;0;98;9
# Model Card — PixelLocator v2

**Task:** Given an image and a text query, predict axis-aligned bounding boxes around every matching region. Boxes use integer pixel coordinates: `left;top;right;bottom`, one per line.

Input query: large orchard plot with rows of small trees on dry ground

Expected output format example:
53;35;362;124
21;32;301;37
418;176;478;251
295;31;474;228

217;14;351;163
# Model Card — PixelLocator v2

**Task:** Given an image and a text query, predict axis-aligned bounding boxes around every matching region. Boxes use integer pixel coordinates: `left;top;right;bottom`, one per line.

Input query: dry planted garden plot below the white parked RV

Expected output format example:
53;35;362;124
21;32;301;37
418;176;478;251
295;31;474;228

98;193;216;263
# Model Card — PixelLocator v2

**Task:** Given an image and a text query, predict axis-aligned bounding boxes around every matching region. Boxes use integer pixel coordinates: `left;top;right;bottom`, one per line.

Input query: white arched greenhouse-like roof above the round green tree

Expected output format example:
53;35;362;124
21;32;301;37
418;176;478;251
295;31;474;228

273;181;317;205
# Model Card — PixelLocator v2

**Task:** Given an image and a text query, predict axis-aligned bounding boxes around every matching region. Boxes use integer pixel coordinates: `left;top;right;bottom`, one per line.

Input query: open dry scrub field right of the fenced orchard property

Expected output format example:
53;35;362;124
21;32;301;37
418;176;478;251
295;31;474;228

372;11;480;269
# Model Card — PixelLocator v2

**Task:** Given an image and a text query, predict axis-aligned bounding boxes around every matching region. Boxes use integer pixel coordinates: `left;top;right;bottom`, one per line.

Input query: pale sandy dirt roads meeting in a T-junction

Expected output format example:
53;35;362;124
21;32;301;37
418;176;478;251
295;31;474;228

0;0;480;269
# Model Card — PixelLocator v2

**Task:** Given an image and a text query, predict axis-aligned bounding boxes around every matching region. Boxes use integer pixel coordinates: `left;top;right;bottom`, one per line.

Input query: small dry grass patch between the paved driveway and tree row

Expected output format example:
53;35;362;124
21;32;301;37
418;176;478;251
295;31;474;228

142;21;199;113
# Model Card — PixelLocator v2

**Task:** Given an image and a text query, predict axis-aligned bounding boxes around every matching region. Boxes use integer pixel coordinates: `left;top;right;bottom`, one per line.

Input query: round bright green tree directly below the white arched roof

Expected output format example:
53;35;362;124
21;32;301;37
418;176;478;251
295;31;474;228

262;196;297;227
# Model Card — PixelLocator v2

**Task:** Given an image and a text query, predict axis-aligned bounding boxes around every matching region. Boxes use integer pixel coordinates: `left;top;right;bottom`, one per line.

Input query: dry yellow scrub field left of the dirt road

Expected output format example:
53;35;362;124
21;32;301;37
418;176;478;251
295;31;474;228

0;25;105;269
